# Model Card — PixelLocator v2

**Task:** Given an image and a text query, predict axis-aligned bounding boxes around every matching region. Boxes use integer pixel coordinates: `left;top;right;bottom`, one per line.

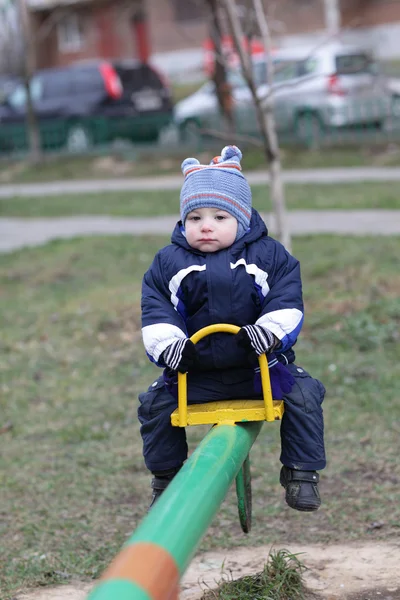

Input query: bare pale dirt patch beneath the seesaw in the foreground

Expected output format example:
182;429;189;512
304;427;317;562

16;540;400;600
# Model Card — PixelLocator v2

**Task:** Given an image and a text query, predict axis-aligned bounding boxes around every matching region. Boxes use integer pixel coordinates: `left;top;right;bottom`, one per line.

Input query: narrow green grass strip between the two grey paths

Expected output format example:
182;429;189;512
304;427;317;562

0;182;400;217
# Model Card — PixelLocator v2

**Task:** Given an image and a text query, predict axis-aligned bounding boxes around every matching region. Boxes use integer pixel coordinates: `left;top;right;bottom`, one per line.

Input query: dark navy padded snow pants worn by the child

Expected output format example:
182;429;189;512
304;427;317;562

138;363;326;473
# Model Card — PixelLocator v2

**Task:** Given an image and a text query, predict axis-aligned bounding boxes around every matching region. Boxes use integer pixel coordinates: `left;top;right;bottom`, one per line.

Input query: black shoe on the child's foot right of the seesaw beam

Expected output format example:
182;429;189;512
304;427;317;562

279;467;321;512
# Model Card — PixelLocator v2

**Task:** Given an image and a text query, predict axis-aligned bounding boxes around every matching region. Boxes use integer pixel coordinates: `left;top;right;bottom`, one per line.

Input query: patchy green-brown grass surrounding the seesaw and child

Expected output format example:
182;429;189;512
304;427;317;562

0;236;400;600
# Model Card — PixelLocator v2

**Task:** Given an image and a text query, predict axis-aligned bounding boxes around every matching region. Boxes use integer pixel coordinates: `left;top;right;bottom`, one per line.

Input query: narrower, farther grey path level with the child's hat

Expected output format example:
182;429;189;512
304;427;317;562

0;167;400;198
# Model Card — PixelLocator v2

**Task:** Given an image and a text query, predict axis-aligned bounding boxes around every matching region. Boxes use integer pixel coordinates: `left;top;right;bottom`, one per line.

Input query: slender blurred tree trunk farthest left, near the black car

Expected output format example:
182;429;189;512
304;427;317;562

18;0;42;164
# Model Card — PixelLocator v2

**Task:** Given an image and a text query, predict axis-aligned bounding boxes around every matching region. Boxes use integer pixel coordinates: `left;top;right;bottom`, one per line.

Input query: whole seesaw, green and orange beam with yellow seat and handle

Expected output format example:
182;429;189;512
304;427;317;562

88;323;284;600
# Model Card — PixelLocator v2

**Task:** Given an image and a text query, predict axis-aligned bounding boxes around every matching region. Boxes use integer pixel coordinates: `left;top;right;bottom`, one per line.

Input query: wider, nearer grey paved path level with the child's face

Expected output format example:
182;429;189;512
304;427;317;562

0;210;400;252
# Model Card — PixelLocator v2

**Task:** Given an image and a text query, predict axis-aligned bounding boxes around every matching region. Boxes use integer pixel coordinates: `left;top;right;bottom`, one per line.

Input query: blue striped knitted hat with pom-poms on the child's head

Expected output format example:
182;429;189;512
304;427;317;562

180;146;251;239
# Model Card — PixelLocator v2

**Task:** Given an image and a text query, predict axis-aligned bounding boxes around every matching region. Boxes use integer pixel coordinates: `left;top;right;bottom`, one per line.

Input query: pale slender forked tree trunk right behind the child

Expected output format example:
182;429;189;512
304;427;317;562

224;0;291;252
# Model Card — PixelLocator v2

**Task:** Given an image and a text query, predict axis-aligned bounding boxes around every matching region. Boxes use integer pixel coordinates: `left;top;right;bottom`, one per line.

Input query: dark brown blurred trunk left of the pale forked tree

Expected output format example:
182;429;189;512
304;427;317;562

206;0;235;138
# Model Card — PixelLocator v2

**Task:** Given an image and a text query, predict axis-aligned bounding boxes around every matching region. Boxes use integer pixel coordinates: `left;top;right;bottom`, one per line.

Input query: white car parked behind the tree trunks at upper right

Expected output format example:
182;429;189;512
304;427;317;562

174;43;391;140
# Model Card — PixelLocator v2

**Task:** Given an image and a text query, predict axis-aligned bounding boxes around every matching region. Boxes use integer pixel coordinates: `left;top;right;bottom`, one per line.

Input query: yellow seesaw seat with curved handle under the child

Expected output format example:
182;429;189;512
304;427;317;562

171;323;284;427
